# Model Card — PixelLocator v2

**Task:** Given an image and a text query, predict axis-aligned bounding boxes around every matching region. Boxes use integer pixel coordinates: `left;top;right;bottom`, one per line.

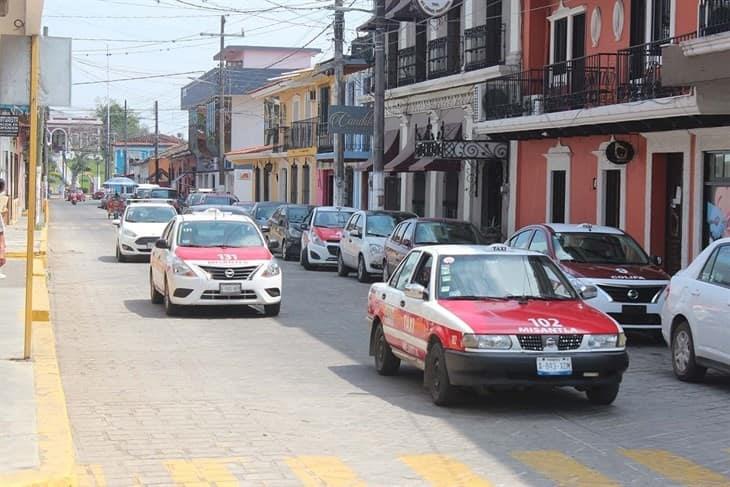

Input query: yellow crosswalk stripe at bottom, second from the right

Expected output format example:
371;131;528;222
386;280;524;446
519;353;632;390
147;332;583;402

512;450;620;487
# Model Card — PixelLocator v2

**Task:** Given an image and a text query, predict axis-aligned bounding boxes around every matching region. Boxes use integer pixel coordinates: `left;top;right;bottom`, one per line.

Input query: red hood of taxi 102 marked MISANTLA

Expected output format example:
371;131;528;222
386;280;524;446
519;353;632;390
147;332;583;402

438;299;618;335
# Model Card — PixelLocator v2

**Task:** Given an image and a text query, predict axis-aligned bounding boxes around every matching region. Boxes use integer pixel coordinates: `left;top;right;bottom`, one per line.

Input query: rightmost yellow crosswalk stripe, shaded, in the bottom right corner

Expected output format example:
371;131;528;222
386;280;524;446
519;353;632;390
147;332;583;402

619;448;730;487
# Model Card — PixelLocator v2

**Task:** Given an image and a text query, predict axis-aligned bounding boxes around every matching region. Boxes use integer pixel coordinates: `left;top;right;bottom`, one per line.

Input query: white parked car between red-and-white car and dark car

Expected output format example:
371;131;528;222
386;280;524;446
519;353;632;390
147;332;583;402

337;211;417;282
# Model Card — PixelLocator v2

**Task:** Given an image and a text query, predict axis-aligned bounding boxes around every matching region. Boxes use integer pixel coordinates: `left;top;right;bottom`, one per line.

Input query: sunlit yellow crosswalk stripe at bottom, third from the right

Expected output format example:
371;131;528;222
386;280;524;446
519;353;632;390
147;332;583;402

400;454;492;487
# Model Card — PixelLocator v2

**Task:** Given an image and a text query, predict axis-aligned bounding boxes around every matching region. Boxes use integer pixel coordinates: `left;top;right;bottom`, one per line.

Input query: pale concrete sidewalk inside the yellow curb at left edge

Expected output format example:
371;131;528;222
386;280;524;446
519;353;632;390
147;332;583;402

0;260;40;476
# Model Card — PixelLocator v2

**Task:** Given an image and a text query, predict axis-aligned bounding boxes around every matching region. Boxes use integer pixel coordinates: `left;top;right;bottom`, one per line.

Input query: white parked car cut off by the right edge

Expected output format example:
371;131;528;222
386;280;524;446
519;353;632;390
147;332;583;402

662;238;730;381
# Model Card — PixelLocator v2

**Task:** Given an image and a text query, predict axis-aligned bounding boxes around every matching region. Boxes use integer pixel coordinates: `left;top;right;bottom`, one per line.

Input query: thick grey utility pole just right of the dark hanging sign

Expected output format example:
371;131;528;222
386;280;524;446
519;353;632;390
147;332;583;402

373;0;385;210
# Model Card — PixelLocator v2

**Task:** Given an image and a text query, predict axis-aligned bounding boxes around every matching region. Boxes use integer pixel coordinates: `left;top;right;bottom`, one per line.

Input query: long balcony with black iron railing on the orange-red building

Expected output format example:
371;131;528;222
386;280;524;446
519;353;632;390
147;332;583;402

483;34;693;120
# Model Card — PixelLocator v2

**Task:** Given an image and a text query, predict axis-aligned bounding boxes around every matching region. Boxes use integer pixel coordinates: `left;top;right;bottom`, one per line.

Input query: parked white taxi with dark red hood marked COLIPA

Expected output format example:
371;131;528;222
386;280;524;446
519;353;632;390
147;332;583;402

509;223;669;331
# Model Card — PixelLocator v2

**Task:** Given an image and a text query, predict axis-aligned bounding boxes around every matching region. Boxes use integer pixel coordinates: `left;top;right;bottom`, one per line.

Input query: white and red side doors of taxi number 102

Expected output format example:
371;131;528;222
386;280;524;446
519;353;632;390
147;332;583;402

381;251;421;357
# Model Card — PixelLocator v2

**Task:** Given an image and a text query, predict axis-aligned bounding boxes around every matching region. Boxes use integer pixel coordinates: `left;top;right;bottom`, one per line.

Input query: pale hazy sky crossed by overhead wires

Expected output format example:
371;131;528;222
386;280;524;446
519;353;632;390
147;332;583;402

43;0;372;137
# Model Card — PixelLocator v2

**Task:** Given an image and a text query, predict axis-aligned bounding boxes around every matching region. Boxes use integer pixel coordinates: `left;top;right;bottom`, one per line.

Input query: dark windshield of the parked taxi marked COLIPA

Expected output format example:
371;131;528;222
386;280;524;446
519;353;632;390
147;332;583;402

553;232;649;265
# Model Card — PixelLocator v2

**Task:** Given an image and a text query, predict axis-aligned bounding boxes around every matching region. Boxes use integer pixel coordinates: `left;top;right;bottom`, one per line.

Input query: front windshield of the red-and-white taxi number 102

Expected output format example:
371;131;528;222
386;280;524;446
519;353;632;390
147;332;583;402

438;254;577;300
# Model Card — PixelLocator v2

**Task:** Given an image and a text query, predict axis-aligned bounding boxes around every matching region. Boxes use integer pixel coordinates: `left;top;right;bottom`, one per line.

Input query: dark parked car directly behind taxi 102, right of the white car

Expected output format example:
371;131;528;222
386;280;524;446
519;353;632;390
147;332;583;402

383;218;485;281
